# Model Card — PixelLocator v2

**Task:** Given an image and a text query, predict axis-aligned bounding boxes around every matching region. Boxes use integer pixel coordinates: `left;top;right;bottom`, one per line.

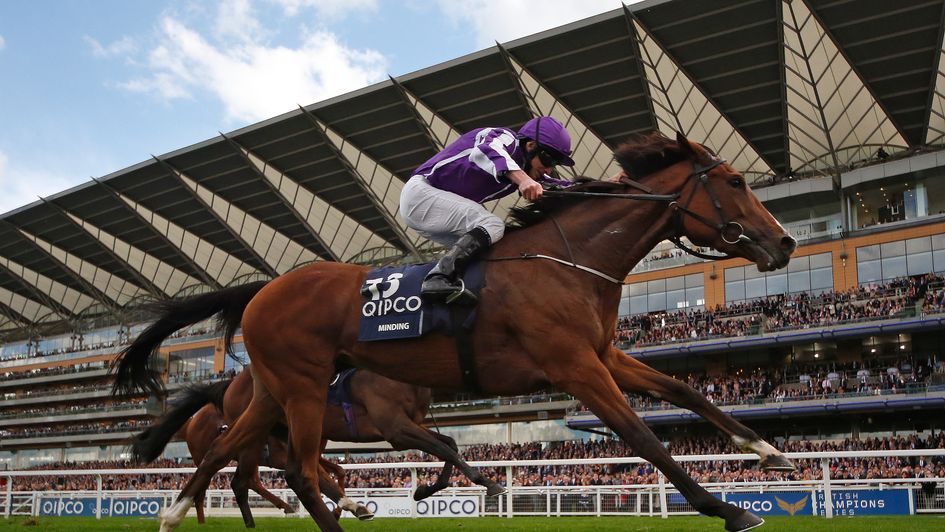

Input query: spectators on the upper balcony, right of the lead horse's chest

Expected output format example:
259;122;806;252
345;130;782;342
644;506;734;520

614;274;945;348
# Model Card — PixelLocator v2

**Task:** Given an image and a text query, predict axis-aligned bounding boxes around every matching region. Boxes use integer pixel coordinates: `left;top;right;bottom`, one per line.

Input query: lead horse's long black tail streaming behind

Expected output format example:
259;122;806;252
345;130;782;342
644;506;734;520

111;281;269;395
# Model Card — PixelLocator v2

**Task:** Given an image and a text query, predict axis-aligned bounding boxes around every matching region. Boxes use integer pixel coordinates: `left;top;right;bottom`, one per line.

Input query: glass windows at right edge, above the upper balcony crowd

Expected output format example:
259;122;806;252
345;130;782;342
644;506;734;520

856;234;945;284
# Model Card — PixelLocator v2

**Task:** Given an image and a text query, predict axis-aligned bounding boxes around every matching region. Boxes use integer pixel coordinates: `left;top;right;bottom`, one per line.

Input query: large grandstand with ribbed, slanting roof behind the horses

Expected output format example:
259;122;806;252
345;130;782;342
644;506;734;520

0;0;945;524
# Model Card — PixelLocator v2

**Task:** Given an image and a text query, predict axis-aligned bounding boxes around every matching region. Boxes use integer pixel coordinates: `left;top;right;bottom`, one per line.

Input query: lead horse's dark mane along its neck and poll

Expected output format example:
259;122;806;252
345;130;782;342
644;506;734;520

508;131;686;231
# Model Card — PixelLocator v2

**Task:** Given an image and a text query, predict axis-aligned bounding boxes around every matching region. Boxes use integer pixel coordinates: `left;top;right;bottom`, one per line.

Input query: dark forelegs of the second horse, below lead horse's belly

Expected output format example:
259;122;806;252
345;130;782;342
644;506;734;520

384;418;506;501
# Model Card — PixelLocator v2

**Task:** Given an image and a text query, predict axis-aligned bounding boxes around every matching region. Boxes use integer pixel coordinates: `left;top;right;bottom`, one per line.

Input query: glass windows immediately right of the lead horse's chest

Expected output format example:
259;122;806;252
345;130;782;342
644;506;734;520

619;273;705;316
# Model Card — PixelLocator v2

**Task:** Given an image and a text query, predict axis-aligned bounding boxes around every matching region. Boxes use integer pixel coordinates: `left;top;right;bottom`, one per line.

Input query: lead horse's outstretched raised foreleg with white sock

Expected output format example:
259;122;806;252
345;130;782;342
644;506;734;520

605;347;794;471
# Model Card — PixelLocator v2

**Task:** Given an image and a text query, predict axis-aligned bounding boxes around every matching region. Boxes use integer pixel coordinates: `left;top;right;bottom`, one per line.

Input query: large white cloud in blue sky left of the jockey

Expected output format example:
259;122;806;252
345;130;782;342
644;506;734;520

118;10;388;122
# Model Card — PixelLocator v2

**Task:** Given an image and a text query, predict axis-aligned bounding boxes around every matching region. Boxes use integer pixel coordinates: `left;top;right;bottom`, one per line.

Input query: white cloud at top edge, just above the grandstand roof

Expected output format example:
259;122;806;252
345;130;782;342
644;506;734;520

438;0;639;48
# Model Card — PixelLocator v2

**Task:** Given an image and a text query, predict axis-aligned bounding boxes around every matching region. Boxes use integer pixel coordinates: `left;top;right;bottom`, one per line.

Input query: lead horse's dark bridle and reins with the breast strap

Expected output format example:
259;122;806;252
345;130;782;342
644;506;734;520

487;158;751;285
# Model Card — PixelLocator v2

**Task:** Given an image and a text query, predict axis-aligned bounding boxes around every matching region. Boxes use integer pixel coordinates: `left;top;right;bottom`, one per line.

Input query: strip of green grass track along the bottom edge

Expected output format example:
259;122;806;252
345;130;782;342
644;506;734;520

0;516;945;532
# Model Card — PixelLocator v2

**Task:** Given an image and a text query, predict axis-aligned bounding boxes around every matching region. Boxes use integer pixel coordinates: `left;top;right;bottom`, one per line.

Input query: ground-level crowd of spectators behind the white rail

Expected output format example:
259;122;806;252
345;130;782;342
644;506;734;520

14;432;945;491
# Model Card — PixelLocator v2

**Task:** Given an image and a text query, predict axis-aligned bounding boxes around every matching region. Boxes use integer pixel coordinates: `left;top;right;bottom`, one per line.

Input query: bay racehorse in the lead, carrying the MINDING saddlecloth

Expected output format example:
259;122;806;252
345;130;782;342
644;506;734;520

116;133;797;531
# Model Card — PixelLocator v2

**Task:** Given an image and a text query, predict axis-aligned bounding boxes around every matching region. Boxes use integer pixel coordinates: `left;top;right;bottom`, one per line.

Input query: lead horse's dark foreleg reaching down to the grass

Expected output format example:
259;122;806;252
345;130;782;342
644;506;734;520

545;353;764;531
